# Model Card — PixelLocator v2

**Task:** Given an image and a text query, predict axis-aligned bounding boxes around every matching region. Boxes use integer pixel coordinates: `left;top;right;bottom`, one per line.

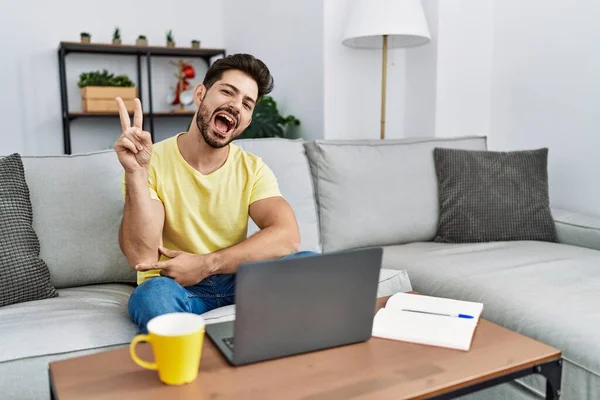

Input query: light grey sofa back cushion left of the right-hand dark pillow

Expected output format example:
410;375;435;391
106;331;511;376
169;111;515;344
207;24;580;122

306;137;486;252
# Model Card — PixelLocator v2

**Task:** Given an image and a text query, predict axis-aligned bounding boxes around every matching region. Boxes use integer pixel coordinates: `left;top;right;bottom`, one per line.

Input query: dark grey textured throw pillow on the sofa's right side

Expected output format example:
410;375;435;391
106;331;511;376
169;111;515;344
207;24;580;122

434;148;557;243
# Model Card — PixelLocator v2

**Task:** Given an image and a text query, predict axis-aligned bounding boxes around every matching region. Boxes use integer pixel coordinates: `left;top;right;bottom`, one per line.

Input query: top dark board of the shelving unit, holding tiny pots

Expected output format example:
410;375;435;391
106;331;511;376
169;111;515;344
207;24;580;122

59;42;225;60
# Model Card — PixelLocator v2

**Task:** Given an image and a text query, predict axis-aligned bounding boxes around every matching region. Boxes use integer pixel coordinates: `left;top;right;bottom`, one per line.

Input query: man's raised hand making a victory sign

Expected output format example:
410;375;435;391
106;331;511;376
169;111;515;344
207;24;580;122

115;97;152;172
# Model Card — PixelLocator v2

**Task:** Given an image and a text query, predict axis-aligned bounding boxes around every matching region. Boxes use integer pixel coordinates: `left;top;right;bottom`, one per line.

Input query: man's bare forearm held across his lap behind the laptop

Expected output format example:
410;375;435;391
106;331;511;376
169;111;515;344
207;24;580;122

209;226;300;275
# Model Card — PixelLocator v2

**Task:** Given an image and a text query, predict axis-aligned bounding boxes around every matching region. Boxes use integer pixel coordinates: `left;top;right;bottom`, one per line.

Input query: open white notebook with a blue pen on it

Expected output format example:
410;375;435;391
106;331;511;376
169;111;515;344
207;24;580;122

373;293;483;350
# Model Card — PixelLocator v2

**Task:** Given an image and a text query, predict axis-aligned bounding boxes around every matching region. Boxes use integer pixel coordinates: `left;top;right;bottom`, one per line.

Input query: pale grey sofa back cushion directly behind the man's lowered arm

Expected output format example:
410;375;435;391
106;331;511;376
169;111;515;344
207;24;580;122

235;139;321;252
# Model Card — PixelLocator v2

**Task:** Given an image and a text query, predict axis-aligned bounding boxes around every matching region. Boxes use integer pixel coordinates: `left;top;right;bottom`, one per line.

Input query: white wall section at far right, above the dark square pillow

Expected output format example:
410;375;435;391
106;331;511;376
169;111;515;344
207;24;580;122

489;0;600;216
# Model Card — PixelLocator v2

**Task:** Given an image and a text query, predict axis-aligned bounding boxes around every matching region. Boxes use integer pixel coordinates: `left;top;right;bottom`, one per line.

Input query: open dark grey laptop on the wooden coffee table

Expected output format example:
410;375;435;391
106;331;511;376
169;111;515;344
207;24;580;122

206;248;383;365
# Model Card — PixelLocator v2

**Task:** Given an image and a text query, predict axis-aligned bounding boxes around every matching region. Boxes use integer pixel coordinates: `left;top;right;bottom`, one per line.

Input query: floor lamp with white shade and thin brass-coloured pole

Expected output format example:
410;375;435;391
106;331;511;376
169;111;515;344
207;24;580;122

342;0;431;139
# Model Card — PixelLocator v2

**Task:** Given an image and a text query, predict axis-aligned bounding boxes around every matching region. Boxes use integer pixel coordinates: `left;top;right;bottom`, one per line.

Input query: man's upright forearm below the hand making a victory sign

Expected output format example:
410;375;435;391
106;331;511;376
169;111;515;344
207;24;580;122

119;169;165;268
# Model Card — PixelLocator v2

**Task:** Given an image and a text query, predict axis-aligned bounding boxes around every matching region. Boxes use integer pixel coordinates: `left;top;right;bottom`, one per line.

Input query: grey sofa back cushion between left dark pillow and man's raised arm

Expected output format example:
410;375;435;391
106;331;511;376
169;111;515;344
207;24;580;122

23;150;136;288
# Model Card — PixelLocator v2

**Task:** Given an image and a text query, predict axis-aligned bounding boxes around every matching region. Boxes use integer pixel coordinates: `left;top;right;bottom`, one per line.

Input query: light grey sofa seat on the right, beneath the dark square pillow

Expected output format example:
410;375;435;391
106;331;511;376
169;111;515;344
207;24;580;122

383;241;600;398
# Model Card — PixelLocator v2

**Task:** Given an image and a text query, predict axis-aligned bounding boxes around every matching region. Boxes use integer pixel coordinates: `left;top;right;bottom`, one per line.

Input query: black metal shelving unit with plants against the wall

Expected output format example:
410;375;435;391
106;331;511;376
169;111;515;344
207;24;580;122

58;42;226;154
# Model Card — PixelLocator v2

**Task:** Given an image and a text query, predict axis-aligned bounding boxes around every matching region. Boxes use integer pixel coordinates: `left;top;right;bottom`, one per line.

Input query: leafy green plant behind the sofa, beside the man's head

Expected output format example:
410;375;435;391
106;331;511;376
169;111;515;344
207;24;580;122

240;96;300;139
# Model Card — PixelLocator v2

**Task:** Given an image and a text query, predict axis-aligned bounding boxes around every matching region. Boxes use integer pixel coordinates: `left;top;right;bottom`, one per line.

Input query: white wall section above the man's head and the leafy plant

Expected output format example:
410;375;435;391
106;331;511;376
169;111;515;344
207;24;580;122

223;0;324;139
